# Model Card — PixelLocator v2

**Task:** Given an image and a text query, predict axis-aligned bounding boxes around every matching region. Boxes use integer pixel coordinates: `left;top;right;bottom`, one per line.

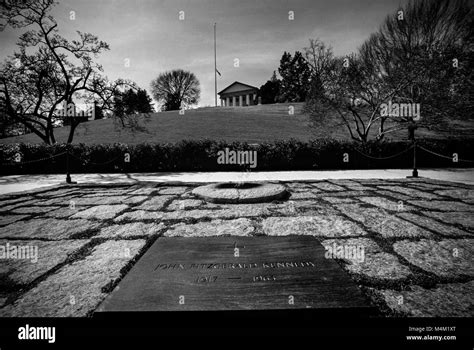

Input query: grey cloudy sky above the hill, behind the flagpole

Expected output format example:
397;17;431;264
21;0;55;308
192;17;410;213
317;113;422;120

0;0;406;106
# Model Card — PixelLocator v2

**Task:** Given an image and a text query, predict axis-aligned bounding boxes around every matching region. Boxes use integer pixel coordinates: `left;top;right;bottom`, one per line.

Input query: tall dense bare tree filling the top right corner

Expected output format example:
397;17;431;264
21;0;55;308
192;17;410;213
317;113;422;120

360;0;474;127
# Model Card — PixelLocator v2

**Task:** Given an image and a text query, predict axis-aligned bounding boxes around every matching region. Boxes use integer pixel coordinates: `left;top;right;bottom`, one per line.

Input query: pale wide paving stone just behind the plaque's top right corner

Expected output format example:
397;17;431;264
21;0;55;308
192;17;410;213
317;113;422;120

262;215;367;237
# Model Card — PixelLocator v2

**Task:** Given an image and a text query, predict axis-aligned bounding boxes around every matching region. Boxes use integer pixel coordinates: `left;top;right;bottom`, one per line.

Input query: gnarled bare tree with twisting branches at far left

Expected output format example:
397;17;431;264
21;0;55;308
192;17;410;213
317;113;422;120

0;0;134;144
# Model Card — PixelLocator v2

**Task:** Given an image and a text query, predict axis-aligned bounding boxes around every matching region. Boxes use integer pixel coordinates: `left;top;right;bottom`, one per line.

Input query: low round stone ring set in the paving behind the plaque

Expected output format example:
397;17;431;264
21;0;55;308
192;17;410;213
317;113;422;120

192;182;288;204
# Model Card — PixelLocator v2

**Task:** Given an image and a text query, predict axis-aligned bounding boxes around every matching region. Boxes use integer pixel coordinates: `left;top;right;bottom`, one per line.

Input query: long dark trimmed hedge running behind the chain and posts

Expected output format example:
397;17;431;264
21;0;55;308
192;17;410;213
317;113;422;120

0;139;474;175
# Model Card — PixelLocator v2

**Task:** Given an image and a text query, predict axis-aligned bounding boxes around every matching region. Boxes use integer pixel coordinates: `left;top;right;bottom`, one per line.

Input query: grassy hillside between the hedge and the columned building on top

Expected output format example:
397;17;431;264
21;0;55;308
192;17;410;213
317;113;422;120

0;103;474;144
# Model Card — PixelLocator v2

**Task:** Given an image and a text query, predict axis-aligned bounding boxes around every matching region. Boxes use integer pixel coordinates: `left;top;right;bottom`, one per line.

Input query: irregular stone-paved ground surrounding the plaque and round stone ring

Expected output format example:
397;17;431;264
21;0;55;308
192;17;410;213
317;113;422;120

0;179;474;317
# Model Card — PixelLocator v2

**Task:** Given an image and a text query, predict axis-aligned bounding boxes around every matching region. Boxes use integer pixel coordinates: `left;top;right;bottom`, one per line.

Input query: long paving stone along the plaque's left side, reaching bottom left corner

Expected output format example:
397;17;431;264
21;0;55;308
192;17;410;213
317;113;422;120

0;239;145;317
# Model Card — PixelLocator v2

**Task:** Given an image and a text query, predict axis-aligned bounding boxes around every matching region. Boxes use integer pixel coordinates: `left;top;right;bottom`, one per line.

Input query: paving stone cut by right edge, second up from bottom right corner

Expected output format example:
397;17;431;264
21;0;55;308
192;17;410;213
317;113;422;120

393;239;474;277
